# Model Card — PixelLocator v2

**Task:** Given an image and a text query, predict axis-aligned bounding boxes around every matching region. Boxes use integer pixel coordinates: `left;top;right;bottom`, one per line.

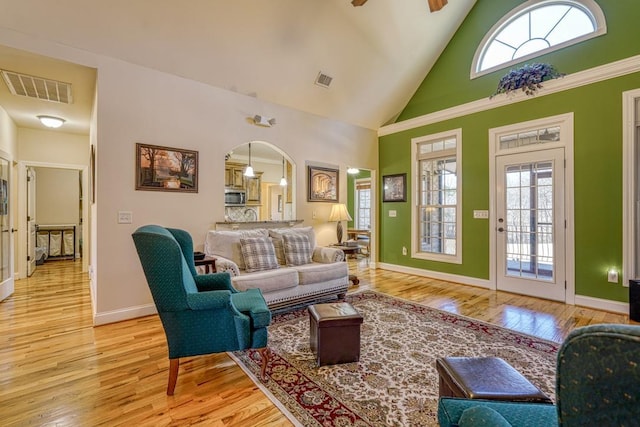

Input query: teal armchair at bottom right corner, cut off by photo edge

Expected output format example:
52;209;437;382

438;324;640;427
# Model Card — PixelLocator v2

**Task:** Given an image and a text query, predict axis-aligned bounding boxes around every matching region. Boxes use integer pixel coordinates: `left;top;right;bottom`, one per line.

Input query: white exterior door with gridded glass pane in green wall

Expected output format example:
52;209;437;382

495;148;566;301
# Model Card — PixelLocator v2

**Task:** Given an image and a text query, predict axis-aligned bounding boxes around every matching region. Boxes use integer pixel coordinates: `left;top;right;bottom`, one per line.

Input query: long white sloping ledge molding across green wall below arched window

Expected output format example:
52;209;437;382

378;55;640;137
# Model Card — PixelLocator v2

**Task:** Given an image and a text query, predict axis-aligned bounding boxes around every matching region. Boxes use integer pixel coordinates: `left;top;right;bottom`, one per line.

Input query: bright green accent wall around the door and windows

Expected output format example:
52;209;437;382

379;0;640;302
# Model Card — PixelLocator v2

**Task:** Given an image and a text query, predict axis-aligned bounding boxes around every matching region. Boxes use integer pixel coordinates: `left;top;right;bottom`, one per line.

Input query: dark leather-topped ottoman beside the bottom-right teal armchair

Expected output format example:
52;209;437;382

436;357;553;403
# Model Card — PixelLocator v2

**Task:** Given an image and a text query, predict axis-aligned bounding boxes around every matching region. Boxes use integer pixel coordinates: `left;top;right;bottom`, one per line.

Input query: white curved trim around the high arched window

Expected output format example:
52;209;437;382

470;0;607;80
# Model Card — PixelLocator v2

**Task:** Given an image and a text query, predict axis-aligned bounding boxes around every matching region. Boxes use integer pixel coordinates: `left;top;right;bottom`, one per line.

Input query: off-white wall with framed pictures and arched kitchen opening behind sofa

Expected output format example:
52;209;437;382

0;28;377;324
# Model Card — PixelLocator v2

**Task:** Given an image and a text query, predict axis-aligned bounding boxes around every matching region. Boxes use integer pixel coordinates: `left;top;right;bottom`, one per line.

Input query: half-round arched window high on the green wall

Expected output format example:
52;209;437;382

471;0;606;78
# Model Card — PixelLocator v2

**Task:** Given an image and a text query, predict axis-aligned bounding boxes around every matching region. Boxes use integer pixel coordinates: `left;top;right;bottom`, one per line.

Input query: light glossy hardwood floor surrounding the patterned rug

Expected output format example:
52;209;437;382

0;260;633;426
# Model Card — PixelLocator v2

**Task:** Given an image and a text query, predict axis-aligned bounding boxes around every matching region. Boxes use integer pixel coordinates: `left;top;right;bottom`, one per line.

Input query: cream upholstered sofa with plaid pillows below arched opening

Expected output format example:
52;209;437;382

204;227;349;310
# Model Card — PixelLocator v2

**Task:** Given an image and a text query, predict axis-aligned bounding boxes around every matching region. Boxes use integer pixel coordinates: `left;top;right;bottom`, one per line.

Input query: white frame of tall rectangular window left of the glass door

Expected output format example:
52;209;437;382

410;128;462;264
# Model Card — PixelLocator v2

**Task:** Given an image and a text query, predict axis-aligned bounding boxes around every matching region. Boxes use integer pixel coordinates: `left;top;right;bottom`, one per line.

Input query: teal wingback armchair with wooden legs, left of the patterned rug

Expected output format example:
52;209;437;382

132;225;271;395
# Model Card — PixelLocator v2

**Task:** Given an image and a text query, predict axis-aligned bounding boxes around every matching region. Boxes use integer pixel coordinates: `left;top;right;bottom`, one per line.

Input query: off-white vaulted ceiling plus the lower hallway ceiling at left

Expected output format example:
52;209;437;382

0;0;476;133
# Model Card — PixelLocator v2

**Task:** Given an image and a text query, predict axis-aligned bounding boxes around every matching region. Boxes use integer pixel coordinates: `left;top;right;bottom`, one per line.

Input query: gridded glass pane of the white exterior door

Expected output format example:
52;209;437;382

505;162;554;281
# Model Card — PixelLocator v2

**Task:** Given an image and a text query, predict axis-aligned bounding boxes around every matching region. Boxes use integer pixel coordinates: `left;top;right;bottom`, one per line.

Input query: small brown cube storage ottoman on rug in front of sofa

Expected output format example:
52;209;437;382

309;302;362;366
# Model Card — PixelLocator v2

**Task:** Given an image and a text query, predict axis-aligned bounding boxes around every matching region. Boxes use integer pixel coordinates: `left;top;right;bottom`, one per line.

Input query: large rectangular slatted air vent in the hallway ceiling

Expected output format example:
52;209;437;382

2;70;73;104
